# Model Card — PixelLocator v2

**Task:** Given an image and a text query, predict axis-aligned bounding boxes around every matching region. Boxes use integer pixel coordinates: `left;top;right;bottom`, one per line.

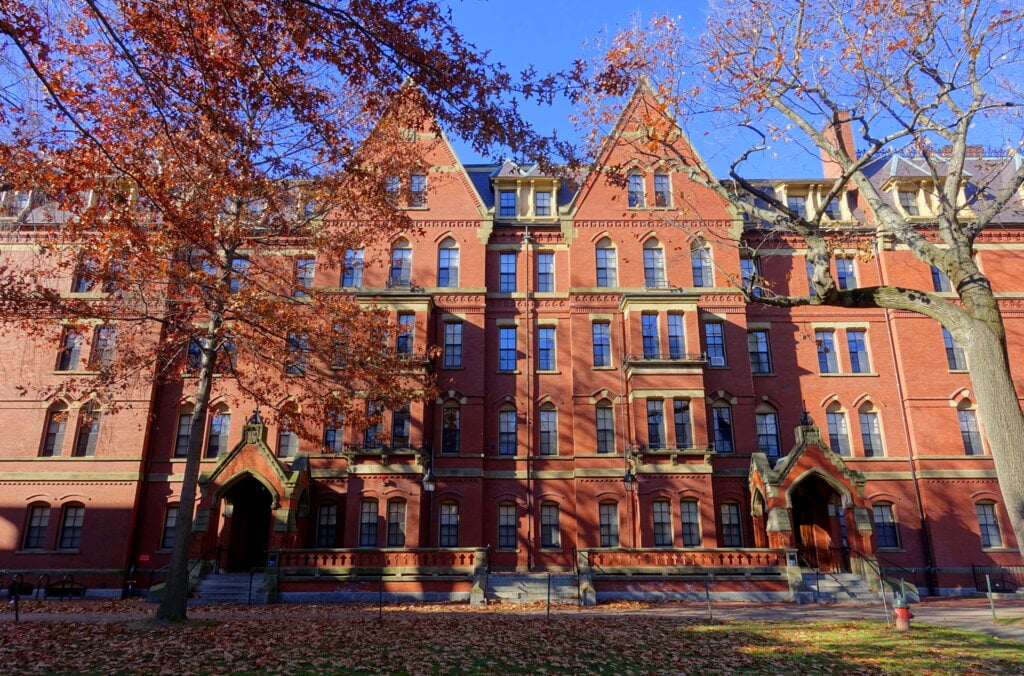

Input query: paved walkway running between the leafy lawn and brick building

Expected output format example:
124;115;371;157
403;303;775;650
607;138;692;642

6;598;1024;642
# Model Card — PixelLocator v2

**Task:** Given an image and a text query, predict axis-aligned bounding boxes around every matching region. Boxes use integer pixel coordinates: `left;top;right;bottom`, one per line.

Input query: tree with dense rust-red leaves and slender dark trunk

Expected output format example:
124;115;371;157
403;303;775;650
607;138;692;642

0;0;543;621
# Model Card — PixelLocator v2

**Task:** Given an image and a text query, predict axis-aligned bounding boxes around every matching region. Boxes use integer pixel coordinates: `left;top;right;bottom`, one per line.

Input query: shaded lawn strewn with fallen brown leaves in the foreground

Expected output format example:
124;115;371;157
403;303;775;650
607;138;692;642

0;602;1024;674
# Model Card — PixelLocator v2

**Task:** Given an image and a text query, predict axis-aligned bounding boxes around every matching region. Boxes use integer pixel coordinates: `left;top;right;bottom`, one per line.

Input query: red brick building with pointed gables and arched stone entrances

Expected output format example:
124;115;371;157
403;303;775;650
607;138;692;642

0;88;1024;599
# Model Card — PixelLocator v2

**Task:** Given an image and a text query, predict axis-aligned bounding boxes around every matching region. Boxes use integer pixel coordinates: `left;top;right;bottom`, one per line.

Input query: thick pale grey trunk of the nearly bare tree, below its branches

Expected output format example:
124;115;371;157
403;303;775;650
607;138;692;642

953;313;1024;547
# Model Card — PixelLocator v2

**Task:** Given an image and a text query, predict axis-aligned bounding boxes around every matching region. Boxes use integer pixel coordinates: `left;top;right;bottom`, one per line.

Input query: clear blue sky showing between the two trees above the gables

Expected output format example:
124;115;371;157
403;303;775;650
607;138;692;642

447;0;705;163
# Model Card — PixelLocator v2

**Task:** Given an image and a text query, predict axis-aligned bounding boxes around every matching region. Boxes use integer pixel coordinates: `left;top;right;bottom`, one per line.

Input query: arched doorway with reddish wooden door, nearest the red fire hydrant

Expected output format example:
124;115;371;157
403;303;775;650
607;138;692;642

790;476;850;573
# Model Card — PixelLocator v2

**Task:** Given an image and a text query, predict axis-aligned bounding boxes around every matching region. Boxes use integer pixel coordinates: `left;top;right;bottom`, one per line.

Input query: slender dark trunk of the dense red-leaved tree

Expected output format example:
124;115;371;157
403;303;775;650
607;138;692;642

156;331;217;622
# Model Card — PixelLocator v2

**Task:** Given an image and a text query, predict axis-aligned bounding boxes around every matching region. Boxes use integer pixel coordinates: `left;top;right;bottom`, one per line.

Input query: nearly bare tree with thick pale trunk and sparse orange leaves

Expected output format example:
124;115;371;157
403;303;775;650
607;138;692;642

573;0;1024;542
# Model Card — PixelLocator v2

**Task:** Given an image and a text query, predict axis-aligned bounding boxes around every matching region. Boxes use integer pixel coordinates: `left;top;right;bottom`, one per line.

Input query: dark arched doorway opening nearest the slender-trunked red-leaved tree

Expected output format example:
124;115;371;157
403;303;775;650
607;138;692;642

219;476;273;572
